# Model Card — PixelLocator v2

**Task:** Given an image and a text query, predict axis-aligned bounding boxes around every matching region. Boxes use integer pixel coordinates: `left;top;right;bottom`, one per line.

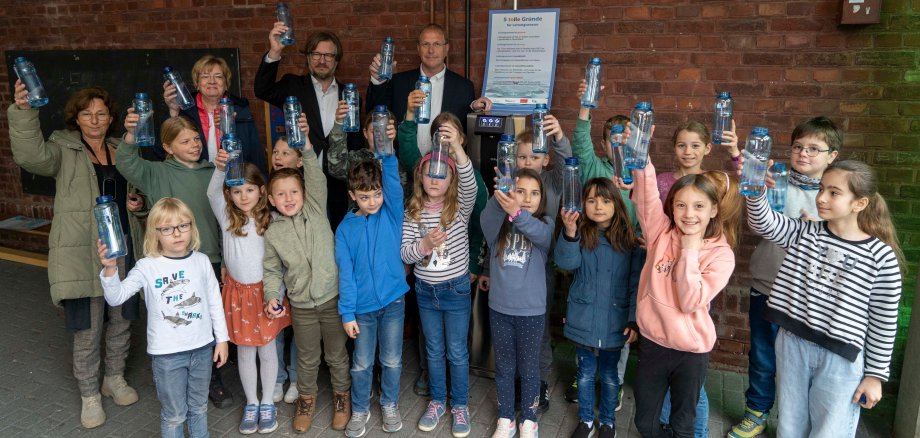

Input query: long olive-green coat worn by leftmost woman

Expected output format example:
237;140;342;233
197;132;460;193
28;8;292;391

7;105;144;306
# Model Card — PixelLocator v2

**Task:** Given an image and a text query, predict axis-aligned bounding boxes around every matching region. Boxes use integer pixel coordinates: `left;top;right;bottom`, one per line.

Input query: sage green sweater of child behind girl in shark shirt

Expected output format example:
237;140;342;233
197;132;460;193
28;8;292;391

115;141;221;263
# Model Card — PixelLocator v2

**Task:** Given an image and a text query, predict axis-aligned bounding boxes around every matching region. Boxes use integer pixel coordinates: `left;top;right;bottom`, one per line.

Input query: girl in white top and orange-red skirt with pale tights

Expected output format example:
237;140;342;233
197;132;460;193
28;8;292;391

208;156;291;435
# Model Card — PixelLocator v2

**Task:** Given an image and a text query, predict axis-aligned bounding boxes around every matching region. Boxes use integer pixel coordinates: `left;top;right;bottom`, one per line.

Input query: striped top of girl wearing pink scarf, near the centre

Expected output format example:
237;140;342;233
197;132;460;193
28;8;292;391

399;161;476;283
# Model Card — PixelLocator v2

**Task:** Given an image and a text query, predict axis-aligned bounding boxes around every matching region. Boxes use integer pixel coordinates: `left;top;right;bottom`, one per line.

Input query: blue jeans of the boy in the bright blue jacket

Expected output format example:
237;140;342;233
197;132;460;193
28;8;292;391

351;297;406;412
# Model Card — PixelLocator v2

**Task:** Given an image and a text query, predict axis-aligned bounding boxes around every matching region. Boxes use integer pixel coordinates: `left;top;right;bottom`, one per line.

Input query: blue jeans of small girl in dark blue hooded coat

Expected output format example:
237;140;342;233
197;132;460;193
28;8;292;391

575;345;621;426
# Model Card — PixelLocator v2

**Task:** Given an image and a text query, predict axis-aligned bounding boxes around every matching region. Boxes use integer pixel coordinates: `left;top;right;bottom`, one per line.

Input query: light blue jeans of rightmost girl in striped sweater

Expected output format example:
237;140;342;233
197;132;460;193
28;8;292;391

776;330;864;438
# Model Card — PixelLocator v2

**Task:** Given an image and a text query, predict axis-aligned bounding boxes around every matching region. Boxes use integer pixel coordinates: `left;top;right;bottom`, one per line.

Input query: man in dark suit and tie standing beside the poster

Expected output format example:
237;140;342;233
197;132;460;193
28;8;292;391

367;23;492;155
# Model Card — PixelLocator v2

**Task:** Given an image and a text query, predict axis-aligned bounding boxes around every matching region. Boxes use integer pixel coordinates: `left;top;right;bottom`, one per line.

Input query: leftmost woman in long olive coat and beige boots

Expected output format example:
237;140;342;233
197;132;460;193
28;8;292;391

7;80;143;428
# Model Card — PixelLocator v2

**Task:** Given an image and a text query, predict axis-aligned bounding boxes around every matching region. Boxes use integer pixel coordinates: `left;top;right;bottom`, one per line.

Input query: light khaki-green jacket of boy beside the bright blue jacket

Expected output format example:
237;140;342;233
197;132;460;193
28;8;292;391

262;149;339;309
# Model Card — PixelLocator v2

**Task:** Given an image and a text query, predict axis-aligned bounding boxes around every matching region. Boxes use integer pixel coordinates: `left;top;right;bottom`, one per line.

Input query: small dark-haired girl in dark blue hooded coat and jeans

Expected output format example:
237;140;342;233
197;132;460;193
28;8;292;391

554;178;645;438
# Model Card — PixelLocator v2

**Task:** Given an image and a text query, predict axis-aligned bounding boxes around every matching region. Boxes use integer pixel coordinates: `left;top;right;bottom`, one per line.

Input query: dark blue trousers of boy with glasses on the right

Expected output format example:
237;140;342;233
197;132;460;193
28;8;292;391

744;289;779;412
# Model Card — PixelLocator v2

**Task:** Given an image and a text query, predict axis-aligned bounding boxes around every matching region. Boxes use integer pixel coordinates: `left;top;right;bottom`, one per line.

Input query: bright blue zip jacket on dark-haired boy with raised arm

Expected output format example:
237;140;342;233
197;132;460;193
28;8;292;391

335;155;409;323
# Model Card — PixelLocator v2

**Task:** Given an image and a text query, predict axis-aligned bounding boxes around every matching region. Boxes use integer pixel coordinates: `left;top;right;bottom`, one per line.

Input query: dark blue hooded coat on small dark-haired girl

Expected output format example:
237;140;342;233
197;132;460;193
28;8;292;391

554;233;645;349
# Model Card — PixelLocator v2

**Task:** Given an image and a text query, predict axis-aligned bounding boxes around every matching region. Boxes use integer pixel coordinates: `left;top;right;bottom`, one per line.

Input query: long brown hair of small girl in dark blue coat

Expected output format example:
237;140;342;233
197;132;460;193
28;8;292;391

581;178;639;252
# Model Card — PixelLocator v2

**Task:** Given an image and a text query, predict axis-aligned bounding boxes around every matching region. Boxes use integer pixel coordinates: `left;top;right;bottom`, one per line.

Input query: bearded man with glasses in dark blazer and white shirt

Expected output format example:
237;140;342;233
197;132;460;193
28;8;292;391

255;26;363;231
